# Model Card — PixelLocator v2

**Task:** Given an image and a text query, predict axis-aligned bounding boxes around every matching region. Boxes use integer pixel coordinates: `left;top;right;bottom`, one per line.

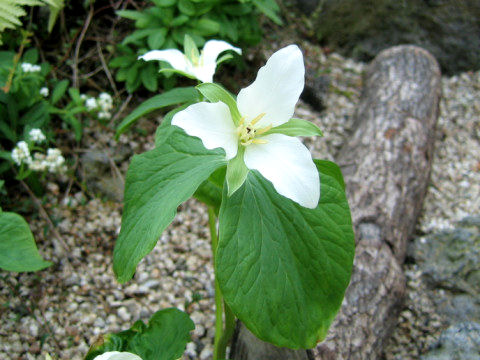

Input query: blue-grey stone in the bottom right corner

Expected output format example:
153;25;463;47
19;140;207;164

420;322;480;360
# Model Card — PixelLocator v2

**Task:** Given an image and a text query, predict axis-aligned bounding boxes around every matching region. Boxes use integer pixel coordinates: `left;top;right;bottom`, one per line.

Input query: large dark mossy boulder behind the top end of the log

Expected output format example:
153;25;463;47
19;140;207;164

313;0;480;74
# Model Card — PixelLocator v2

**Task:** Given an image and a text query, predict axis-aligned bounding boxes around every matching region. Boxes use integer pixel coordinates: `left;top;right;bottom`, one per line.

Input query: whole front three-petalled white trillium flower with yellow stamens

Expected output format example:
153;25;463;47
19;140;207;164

172;45;320;208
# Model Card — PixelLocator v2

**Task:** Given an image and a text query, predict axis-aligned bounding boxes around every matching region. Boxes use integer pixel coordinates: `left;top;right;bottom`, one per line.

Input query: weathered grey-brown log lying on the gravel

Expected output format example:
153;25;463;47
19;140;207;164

232;46;441;360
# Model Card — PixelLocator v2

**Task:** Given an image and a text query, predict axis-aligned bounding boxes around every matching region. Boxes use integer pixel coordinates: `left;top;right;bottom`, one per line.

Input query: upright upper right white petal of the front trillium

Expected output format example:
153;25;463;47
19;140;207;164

237;45;305;127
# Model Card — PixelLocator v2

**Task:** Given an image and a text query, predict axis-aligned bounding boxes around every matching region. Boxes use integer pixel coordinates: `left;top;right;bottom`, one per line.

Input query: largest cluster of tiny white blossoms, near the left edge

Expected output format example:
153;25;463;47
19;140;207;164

12;137;66;173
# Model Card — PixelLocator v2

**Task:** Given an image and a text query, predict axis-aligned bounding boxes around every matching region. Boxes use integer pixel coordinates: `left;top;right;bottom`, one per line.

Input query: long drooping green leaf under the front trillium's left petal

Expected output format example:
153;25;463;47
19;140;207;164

113;126;226;283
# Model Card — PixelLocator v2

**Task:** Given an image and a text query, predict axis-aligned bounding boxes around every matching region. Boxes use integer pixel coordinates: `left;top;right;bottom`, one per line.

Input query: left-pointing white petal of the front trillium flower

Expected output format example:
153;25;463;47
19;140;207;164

172;102;238;160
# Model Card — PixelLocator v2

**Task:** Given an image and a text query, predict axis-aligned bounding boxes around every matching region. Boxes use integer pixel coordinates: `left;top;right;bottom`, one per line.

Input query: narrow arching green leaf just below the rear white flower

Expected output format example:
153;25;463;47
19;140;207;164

115;87;198;138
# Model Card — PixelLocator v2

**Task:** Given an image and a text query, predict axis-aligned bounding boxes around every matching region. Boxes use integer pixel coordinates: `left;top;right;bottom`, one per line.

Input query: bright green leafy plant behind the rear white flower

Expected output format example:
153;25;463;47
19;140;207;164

110;0;281;92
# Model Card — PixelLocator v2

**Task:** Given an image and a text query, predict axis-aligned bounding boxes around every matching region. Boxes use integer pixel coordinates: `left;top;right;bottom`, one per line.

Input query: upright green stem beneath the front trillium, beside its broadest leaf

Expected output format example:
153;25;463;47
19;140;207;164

208;206;227;360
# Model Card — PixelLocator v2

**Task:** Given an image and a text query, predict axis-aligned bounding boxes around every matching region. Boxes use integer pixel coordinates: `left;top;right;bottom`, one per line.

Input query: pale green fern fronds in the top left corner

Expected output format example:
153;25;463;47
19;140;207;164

0;0;65;45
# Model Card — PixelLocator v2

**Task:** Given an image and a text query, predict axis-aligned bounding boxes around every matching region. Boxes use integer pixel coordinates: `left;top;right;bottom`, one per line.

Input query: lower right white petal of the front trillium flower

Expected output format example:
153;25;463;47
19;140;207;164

245;134;320;209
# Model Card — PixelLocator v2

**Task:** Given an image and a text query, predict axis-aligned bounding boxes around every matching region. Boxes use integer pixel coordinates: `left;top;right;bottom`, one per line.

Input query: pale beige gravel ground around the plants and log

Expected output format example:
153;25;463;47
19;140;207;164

0;43;480;360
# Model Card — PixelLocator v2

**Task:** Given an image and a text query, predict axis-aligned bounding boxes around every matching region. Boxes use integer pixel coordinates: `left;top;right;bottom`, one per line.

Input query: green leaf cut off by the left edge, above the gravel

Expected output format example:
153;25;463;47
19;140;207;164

0;212;52;272
